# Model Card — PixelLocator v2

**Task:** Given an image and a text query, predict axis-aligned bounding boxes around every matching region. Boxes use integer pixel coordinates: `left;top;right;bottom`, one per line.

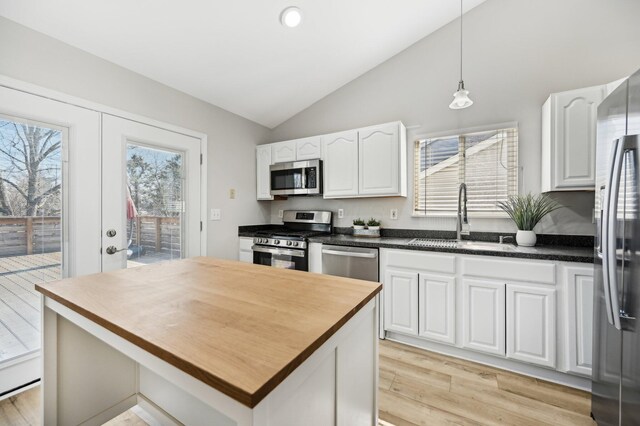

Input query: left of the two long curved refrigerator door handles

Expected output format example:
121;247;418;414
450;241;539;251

601;139;622;326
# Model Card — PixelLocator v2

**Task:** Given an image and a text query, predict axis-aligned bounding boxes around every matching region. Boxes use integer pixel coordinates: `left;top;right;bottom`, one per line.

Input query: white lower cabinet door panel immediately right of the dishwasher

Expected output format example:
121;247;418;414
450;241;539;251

383;269;418;335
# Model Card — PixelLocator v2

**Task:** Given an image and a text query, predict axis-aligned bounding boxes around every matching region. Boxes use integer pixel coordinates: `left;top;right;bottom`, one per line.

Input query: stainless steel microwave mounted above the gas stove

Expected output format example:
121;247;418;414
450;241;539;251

269;160;322;195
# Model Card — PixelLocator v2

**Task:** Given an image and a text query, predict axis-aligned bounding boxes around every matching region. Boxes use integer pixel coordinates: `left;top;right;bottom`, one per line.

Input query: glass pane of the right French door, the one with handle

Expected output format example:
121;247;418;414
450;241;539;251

125;143;185;267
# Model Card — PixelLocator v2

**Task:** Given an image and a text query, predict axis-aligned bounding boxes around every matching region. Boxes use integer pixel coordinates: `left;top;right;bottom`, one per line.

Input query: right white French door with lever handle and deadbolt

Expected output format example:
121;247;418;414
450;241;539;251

102;114;201;272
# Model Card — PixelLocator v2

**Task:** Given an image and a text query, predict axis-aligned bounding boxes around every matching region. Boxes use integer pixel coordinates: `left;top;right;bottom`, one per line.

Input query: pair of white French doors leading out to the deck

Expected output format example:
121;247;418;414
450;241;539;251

0;86;203;399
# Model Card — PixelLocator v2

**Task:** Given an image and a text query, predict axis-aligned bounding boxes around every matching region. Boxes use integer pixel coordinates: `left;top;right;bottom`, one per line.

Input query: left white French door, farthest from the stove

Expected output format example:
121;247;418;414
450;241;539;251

0;87;101;399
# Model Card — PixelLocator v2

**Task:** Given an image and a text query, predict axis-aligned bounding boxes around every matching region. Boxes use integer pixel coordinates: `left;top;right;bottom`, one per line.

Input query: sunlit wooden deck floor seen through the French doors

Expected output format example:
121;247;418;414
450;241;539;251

0;252;176;368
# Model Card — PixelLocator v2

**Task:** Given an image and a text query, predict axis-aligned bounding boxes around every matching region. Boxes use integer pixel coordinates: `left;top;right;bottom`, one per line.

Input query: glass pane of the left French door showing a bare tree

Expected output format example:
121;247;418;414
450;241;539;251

0;116;66;376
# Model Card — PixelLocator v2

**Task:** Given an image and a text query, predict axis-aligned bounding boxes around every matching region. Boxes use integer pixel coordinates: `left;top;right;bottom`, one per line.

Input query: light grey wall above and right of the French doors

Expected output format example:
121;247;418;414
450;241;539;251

0;17;269;258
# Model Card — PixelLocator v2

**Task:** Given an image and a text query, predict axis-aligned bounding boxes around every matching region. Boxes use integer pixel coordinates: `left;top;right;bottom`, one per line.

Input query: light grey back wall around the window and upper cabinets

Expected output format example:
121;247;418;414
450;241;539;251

264;0;640;235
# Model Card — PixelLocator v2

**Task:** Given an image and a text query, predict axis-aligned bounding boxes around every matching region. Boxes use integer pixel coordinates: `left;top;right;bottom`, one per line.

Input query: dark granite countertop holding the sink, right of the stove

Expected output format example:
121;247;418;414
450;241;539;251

309;234;593;263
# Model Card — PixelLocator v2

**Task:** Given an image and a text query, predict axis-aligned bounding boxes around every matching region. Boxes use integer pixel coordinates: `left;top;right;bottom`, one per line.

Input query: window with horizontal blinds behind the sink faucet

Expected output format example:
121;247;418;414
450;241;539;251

413;127;518;216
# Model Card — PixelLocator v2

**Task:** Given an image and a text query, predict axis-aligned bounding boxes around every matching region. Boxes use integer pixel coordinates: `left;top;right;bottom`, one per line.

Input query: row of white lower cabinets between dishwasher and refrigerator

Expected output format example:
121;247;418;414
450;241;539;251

380;248;594;386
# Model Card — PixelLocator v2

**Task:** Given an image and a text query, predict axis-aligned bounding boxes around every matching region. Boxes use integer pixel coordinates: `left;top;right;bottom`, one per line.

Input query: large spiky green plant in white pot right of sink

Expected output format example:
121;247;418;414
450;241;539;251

498;194;562;247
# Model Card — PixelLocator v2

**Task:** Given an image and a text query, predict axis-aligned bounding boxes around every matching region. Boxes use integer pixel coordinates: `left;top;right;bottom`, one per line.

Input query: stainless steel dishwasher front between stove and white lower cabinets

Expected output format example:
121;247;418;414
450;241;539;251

322;244;379;282
